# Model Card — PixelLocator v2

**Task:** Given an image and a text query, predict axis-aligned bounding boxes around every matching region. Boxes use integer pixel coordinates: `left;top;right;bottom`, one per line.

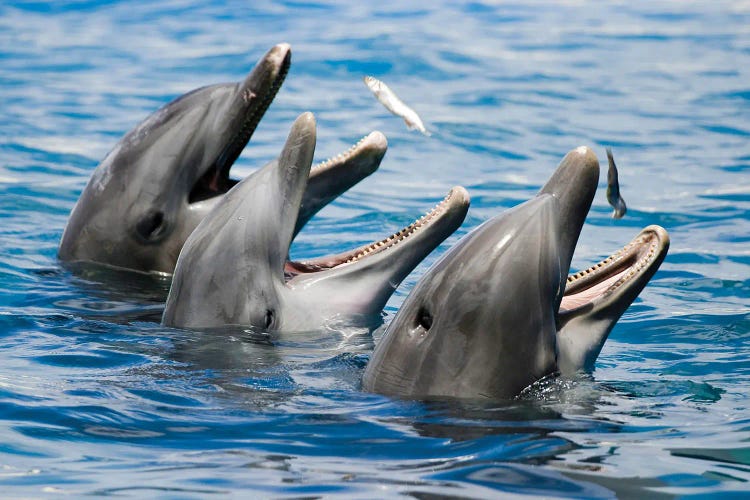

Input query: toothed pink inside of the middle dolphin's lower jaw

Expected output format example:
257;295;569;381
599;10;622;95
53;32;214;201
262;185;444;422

284;186;469;282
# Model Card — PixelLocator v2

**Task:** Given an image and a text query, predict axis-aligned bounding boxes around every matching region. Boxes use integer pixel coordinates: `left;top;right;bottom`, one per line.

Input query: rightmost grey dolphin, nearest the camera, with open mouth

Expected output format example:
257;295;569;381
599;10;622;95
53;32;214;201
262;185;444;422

363;147;669;399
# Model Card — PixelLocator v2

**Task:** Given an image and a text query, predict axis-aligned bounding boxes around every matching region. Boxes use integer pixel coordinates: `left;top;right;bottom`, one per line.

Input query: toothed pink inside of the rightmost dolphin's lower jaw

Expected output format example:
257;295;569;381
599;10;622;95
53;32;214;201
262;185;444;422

558;226;669;321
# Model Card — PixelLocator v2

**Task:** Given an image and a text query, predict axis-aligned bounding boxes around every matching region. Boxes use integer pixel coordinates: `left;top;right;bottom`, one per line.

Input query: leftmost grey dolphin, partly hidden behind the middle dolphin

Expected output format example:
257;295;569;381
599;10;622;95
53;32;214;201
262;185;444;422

58;43;387;273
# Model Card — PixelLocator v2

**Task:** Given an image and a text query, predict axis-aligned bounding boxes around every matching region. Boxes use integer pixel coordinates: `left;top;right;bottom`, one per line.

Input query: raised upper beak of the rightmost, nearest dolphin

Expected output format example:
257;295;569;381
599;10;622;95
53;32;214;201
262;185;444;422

538;146;599;311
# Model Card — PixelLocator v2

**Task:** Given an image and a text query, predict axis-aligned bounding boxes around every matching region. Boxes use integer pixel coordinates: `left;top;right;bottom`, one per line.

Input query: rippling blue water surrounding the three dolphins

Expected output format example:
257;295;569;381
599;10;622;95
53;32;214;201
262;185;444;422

0;0;750;498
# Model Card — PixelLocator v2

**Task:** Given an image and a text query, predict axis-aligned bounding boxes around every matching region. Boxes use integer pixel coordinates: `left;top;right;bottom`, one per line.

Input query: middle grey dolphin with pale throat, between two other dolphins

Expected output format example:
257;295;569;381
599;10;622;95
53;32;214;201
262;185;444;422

162;113;469;332
